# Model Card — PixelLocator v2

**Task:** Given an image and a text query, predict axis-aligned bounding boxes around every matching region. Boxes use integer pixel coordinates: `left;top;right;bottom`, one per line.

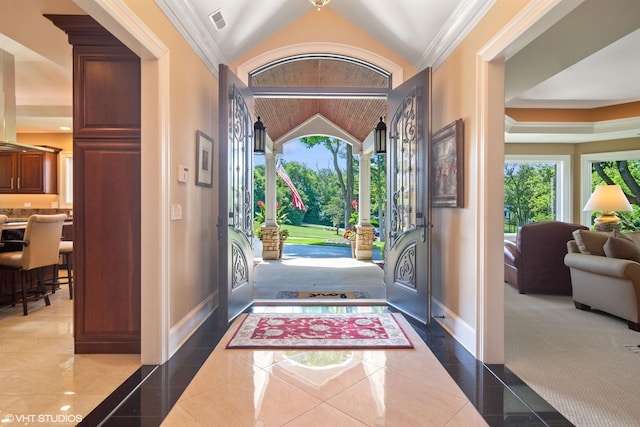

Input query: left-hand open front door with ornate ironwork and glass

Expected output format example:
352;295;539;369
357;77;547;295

218;65;253;322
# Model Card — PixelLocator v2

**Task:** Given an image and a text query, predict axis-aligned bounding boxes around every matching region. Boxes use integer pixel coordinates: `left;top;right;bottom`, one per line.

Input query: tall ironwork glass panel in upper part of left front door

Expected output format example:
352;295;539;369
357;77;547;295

229;85;253;241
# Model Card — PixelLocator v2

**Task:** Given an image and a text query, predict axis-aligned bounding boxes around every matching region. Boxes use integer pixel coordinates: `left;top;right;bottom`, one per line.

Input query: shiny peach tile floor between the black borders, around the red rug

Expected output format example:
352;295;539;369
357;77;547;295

163;307;486;427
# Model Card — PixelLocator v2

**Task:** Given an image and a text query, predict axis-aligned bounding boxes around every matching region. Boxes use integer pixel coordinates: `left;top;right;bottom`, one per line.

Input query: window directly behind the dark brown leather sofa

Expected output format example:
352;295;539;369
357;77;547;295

504;156;571;233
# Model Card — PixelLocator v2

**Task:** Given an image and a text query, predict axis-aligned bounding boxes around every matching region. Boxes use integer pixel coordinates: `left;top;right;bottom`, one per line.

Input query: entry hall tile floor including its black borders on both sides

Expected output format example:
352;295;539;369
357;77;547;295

82;306;572;427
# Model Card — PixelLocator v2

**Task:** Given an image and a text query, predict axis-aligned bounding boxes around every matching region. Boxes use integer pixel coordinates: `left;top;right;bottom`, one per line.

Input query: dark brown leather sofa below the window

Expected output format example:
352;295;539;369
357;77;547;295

504;221;588;295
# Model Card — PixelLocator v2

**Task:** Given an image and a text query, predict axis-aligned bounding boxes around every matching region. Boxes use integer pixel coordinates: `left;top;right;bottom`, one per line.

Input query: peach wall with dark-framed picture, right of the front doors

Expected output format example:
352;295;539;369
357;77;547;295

432;0;529;334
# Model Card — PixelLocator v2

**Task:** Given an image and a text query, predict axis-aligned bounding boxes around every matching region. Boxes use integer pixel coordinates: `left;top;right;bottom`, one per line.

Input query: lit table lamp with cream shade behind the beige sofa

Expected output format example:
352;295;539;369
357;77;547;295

583;185;632;231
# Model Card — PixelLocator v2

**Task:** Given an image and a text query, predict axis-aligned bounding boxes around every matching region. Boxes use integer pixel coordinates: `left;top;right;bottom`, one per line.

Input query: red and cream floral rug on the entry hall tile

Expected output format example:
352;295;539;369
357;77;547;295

227;313;413;349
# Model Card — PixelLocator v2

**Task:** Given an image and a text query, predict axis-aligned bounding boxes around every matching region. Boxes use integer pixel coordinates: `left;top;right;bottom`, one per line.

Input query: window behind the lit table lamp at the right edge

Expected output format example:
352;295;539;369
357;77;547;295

580;150;640;230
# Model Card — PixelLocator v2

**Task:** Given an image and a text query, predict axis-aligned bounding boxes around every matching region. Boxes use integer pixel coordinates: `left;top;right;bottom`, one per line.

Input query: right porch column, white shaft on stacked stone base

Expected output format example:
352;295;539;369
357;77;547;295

356;153;375;260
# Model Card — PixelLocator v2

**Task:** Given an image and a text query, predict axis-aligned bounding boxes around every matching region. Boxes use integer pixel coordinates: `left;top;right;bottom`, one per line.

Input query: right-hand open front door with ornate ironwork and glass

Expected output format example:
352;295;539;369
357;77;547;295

384;68;431;323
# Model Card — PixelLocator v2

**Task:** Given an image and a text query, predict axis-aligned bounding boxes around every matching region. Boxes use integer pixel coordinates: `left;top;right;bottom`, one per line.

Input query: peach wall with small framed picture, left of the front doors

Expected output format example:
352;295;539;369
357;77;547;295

126;0;218;327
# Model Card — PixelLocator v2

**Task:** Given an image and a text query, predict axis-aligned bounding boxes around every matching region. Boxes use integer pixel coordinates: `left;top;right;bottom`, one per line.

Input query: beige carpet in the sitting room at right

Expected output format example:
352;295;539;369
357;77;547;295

505;285;640;427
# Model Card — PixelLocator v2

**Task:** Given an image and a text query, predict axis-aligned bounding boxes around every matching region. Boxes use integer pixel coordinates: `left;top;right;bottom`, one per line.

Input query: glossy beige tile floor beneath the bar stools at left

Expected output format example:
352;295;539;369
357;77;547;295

0;285;140;426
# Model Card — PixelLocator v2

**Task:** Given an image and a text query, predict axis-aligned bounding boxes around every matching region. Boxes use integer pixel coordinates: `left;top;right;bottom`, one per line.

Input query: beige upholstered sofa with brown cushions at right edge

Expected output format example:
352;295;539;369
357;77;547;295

564;231;640;332
